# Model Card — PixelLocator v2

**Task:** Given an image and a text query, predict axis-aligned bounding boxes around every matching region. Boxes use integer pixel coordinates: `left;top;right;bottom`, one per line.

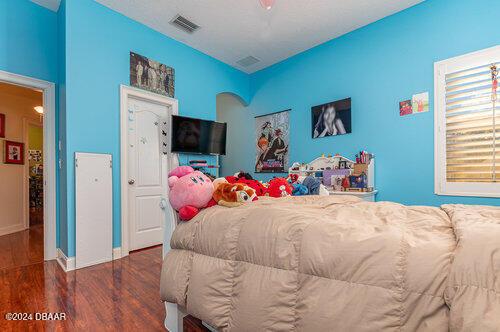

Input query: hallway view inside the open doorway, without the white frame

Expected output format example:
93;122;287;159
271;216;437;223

0;82;44;269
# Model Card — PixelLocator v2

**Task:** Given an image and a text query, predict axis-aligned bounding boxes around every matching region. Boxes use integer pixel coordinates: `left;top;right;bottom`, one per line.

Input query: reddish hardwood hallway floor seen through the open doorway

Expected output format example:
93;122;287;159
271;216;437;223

0;225;43;270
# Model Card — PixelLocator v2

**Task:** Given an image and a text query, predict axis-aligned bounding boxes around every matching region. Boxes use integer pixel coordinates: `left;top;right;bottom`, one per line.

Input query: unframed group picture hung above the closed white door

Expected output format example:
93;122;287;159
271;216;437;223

130;52;175;98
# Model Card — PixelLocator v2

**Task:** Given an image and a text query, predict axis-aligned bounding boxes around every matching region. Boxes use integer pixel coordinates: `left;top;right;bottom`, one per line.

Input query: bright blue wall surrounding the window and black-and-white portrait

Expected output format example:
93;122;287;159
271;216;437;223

236;0;500;205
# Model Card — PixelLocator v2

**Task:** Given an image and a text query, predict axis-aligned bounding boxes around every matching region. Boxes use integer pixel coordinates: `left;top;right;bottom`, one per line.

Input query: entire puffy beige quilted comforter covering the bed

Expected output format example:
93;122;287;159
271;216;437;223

161;196;500;331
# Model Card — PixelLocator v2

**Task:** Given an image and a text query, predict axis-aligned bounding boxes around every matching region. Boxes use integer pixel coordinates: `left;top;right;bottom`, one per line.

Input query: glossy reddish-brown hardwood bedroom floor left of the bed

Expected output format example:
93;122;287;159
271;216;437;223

0;247;165;331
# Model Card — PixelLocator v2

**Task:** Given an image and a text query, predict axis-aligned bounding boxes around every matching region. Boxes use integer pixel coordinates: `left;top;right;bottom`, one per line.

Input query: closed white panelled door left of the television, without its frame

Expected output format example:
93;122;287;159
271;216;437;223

127;97;171;250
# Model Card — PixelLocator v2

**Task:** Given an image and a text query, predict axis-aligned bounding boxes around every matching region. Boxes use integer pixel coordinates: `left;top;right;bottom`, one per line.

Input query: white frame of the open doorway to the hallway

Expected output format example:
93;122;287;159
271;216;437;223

0;70;56;261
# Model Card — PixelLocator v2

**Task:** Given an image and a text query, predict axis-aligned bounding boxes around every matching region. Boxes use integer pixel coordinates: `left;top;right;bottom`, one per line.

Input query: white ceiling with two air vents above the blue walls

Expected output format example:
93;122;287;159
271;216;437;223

32;0;424;73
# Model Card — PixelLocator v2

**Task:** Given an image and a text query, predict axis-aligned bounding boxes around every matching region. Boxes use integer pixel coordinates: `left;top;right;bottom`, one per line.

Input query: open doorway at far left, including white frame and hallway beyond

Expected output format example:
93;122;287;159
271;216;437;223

0;71;56;269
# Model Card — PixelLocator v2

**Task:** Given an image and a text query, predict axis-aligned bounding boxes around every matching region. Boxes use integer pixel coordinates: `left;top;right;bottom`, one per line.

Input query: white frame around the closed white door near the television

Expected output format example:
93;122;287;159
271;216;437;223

120;85;179;257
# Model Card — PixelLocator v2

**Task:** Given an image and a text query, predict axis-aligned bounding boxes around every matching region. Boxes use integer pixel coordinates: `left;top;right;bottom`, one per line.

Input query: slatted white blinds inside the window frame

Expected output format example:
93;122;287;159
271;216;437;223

445;62;500;183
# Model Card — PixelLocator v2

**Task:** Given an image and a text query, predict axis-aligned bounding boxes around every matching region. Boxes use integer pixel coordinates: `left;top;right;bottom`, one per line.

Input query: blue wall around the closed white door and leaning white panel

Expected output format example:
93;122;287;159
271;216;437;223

65;0;249;256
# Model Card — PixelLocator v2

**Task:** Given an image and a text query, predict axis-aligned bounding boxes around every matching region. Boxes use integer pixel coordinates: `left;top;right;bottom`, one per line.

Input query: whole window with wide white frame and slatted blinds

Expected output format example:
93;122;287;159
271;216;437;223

434;46;500;197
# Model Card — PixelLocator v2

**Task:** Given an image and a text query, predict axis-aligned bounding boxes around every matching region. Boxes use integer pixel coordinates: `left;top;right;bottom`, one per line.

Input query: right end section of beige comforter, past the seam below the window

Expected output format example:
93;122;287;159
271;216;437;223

442;205;500;332
